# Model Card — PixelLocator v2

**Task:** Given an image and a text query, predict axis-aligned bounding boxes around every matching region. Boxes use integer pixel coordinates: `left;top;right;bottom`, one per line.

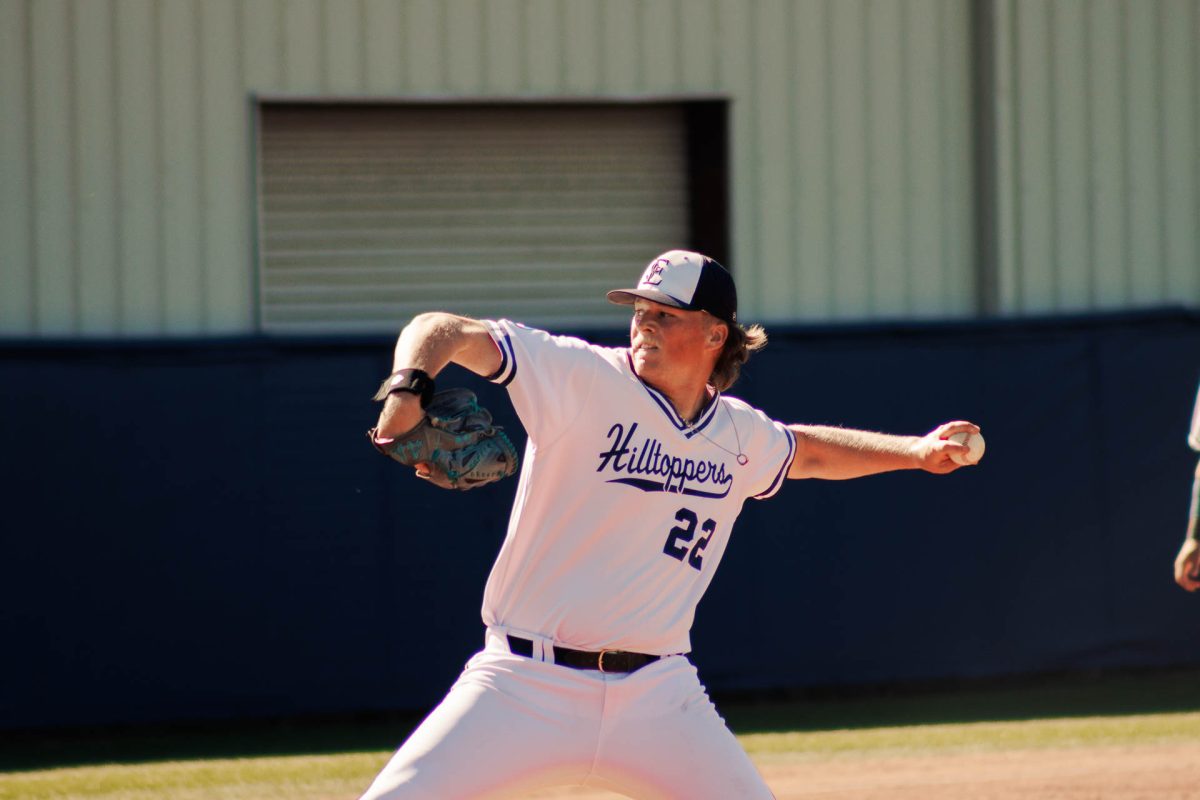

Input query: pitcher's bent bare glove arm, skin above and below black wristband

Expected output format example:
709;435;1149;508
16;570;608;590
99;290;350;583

376;312;500;439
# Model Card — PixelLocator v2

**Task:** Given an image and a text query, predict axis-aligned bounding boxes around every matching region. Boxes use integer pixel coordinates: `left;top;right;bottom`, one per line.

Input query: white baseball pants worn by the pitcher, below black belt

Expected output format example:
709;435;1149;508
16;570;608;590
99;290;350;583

362;630;773;800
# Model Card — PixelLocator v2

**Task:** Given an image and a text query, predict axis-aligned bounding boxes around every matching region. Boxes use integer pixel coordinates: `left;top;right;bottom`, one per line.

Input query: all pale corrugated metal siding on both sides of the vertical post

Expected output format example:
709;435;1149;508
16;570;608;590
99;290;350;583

0;0;1200;336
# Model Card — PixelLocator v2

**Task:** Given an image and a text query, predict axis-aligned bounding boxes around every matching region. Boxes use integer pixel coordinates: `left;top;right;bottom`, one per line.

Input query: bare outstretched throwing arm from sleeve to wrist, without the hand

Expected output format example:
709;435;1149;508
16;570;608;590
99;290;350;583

788;425;920;480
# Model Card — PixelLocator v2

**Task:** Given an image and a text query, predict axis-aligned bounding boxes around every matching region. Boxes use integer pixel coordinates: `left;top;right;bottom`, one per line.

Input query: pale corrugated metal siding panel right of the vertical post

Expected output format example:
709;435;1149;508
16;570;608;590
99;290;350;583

996;0;1200;313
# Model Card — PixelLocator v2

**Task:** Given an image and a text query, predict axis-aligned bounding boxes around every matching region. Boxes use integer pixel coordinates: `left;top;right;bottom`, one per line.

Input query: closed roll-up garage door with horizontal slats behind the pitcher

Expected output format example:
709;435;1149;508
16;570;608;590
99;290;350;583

259;103;689;333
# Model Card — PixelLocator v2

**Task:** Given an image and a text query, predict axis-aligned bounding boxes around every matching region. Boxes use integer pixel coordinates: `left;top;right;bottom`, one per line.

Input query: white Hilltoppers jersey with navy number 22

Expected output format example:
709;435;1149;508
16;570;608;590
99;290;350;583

482;320;796;655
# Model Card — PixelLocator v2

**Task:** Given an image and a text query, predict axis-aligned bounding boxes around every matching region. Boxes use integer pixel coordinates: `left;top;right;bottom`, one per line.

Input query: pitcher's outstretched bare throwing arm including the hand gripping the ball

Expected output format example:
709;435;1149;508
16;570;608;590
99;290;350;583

787;420;979;480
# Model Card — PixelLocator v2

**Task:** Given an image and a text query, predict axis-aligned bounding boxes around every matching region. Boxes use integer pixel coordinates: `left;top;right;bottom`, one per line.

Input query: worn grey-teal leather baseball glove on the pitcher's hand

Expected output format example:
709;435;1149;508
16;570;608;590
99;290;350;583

367;389;517;489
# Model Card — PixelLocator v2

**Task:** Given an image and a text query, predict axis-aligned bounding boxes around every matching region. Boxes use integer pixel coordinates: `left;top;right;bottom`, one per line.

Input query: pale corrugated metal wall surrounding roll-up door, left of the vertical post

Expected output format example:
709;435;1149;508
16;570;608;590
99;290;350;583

0;0;973;337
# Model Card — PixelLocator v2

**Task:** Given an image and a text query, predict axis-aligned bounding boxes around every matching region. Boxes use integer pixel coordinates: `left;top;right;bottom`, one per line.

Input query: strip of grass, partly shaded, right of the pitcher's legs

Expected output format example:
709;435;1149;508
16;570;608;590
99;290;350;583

725;670;1200;758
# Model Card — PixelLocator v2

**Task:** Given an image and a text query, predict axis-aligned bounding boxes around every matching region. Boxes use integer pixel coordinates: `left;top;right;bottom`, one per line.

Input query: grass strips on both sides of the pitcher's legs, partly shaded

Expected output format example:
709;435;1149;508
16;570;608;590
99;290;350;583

7;670;1200;800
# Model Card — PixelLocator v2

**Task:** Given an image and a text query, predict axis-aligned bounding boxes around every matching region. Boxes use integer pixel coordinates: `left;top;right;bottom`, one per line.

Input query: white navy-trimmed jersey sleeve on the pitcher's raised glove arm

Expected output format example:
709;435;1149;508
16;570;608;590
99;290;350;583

482;319;601;445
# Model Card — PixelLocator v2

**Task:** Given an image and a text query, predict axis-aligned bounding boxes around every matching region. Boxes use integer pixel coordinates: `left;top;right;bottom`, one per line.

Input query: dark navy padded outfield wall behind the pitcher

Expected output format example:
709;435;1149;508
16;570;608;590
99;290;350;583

0;309;1200;729
